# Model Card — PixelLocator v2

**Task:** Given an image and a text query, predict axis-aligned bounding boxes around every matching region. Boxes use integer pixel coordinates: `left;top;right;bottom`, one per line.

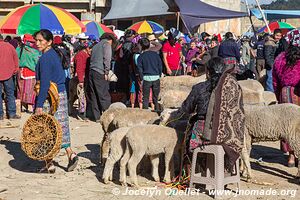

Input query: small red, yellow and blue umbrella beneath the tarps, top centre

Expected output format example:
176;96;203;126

128;20;164;34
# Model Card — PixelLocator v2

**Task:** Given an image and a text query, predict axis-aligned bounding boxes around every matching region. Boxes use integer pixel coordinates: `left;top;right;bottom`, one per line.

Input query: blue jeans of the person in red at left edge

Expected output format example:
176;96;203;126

0;77;16;117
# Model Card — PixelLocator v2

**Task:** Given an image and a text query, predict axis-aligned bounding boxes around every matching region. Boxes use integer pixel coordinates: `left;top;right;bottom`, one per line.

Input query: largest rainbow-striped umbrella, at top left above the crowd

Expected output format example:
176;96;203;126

0;4;85;35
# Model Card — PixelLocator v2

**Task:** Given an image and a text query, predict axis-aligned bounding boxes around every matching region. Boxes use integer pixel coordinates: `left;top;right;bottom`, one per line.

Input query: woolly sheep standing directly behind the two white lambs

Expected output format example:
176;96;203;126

100;108;158;164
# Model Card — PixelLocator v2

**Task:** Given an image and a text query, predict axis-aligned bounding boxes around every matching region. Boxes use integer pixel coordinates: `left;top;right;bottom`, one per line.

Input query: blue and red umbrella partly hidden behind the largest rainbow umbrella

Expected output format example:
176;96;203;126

82;20;114;38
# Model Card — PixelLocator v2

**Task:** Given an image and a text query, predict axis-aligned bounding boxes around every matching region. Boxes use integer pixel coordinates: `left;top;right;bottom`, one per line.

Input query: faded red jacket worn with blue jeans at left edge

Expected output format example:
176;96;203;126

0;40;19;81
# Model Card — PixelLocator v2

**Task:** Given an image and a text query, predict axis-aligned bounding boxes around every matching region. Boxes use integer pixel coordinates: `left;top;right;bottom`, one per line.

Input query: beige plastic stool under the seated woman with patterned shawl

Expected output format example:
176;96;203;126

190;145;240;198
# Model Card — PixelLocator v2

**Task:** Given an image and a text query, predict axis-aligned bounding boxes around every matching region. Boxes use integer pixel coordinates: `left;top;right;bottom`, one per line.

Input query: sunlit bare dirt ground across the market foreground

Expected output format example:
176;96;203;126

0;114;300;200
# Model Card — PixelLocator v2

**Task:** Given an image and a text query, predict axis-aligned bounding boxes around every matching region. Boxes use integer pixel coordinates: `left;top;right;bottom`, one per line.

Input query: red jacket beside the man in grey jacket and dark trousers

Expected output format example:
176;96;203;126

74;50;90;83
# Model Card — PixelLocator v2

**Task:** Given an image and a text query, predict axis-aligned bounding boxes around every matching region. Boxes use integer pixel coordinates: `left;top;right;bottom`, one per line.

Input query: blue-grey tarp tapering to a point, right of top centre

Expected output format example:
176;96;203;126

175;0;247;30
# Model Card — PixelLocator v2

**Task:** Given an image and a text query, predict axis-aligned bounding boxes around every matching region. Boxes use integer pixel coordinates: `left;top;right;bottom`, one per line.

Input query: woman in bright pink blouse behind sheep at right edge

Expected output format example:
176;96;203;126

273;37;300;167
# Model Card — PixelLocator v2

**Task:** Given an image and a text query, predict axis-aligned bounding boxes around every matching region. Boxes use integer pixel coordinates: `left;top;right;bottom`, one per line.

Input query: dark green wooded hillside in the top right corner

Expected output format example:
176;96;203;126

261;0;300;10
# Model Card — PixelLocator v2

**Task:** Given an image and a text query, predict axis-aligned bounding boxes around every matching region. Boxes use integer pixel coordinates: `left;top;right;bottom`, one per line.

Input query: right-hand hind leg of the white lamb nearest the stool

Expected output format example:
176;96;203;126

128;149;145;187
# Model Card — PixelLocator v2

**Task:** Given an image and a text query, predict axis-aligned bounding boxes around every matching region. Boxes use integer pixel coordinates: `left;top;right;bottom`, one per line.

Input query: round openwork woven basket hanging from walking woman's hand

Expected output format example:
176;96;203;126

21;113;62;161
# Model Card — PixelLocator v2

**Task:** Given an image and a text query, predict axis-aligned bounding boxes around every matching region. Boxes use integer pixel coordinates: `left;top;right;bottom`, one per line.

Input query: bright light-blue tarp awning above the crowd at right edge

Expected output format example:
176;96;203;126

251;9;300;20
